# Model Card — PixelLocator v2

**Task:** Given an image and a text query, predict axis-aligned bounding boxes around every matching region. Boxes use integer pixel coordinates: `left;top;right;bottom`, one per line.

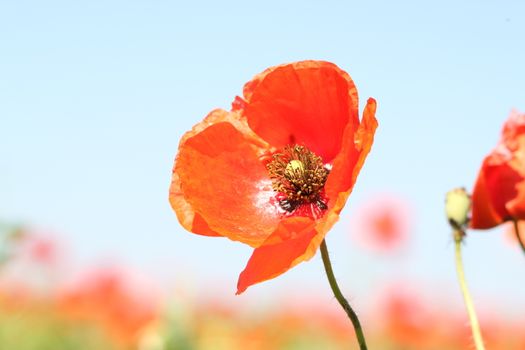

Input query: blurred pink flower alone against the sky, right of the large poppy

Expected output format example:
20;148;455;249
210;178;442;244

351;194;412;252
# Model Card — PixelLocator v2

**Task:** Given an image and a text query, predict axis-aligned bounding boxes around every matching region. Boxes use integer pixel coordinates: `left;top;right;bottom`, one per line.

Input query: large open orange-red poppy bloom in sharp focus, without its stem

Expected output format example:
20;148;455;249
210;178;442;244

169;61;377;294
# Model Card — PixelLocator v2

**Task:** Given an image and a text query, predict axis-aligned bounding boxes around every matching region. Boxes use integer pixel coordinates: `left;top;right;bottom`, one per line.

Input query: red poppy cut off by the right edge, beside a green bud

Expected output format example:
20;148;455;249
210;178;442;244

470;111;525;229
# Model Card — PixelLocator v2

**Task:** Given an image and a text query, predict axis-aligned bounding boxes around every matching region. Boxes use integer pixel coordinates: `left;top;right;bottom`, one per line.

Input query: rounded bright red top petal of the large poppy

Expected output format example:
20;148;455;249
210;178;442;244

244;61;359;163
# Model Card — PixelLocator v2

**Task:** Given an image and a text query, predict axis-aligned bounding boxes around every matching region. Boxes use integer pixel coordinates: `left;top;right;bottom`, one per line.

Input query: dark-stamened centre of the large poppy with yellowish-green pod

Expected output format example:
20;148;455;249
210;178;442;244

266;145;329;212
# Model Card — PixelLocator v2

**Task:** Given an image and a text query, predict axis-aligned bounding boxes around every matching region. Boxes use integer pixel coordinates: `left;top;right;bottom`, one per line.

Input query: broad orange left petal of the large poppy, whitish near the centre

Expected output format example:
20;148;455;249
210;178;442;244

170;110;280;247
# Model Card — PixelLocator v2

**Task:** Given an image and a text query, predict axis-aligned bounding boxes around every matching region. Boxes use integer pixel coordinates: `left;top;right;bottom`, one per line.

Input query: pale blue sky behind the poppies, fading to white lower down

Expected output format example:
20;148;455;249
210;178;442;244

0;0;525;316
